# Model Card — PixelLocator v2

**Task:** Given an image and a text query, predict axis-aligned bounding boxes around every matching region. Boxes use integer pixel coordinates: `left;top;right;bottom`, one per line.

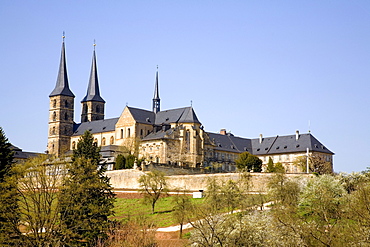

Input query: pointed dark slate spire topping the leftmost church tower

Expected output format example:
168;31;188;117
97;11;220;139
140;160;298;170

49;32;75;97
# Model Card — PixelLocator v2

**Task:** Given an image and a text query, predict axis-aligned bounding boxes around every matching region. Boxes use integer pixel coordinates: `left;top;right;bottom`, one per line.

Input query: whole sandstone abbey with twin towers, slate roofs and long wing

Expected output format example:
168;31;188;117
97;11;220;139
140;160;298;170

47;40;334;173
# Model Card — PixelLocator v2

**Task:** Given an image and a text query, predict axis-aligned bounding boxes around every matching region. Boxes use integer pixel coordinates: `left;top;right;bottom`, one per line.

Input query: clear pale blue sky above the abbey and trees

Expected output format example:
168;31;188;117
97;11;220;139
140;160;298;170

0;0;370;172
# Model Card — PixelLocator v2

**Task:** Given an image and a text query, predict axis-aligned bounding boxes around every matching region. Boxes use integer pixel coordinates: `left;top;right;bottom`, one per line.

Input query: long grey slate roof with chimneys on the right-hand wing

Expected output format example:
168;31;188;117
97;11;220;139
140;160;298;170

207;133;334;155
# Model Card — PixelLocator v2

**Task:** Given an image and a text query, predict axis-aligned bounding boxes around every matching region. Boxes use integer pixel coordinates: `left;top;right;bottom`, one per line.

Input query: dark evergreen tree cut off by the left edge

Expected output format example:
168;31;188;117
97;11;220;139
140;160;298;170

0;127;19;246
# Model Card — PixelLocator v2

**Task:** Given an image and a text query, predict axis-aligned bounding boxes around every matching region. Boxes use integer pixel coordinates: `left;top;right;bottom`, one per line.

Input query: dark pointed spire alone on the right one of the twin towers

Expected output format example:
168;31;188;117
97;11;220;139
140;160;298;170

81;41;105;103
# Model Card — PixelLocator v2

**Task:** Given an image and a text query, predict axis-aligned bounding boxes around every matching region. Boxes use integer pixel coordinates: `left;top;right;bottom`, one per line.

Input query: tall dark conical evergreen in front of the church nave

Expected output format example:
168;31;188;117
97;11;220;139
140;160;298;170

60;131;115;246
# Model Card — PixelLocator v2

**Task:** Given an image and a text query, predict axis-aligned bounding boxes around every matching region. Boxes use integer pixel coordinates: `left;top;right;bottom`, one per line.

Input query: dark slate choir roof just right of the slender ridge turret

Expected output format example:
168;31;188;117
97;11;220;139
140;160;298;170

155;107;200;125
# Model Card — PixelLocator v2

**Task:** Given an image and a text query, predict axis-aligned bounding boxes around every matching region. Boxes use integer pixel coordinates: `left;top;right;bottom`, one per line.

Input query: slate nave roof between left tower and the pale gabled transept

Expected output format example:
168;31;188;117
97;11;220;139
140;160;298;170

73;118;119;136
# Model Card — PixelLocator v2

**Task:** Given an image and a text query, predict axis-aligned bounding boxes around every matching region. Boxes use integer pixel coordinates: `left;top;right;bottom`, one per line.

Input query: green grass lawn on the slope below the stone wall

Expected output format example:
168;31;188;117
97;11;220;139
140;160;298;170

111;196;204;227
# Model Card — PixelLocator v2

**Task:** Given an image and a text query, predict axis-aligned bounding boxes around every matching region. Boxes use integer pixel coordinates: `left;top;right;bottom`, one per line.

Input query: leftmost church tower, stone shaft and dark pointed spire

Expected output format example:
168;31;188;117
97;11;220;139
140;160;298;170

48;35;75;156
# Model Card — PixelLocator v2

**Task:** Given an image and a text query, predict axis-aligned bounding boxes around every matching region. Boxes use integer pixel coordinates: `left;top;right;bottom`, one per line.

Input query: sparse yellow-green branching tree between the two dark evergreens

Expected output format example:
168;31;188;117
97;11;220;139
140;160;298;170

14;156;66;246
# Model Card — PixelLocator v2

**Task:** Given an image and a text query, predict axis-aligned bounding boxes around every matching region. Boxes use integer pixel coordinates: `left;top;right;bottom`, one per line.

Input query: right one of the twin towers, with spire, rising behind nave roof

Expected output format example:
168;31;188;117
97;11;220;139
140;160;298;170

81;44;105;123
